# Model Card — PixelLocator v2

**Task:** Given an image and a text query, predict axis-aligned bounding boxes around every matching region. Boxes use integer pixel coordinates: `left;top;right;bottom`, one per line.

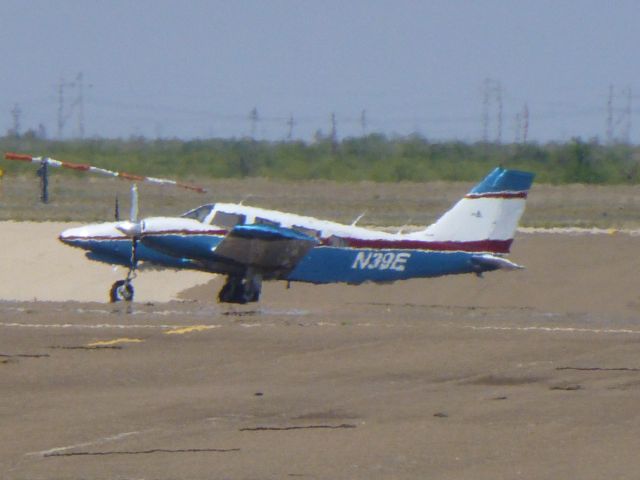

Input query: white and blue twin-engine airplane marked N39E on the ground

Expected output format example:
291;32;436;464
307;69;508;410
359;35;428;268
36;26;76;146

59;167;534;304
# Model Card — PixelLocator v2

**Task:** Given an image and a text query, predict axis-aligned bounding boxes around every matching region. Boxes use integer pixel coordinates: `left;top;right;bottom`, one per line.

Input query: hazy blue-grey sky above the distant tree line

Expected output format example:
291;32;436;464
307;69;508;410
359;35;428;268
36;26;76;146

0;0;640;143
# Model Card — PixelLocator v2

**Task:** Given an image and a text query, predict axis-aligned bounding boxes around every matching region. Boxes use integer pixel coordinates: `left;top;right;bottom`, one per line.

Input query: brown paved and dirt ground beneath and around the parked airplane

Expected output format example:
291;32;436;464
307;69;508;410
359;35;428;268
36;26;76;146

0;223;640;480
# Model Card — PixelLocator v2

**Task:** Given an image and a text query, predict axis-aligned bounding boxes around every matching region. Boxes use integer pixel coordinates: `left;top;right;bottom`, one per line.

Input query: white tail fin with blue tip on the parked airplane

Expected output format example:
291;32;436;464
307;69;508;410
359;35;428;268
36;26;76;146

404;167;534;253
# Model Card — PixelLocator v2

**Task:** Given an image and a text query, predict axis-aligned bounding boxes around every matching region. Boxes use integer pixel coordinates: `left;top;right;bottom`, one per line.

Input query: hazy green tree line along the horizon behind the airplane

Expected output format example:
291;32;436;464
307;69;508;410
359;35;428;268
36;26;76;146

0;134;640;184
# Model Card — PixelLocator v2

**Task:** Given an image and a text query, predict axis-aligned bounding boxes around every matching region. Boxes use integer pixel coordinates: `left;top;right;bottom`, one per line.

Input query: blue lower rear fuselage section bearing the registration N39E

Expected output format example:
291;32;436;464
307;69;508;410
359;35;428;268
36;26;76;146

287;247;478;284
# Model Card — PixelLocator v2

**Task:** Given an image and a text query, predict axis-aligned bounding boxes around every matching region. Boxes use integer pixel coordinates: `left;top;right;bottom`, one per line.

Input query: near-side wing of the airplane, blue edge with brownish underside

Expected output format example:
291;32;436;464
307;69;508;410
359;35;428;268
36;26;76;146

213;224;319;271
